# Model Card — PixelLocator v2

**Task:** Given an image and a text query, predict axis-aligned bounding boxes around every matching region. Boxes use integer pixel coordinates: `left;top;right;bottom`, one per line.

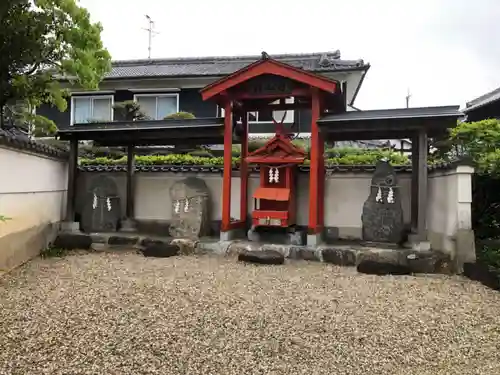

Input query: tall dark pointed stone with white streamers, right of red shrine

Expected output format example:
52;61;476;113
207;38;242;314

361;161;404;243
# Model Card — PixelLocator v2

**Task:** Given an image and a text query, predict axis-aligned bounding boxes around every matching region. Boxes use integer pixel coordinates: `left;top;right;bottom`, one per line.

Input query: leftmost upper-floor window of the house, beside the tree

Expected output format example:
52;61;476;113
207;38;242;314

71;95;113;125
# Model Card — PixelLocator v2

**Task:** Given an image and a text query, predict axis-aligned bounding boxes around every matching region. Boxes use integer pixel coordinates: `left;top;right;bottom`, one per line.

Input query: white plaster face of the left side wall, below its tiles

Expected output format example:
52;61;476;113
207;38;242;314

0;146;67;236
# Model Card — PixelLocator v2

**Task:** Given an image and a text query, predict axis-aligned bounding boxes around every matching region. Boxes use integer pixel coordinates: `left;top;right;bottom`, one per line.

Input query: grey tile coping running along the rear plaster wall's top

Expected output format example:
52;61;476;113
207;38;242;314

79;161;464;174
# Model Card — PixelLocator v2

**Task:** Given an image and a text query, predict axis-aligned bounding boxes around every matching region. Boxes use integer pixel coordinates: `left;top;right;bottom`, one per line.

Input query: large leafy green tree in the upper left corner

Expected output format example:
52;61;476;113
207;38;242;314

0;0;110;133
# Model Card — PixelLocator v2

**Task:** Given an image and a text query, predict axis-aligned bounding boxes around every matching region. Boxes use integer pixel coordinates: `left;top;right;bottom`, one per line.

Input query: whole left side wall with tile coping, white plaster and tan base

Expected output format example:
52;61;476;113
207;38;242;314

0;144;67;274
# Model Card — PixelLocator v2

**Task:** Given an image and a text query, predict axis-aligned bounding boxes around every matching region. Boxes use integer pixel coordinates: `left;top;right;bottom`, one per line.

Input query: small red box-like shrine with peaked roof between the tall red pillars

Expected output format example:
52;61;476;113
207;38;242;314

246;126;306;228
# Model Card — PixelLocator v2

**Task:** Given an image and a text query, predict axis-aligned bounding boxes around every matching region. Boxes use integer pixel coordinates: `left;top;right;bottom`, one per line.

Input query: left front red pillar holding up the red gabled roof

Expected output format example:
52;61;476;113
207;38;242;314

221;100;233;232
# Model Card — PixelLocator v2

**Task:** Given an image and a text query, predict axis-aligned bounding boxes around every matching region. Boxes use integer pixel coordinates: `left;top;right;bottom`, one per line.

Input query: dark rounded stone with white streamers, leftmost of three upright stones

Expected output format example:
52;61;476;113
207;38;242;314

81;175;121;233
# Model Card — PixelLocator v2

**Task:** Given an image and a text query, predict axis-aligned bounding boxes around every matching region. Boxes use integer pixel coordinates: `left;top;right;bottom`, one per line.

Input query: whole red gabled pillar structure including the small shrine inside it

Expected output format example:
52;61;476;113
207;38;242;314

200;52;345;242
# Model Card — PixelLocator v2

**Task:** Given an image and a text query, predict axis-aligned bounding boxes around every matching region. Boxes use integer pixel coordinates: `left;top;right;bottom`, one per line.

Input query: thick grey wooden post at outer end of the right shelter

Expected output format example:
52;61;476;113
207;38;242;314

417;128;429;241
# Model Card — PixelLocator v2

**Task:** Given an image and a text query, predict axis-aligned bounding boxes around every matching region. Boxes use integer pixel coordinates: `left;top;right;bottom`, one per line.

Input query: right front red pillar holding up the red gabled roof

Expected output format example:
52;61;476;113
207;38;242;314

307;88;323;234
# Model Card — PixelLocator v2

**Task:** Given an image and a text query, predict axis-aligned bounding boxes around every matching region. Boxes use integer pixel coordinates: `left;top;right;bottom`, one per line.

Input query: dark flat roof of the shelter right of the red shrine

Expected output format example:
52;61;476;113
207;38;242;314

318;106;463;141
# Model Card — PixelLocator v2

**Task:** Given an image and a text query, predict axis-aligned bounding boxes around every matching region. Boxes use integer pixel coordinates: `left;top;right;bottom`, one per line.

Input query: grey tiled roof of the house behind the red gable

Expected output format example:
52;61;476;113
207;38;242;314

105;51;370;79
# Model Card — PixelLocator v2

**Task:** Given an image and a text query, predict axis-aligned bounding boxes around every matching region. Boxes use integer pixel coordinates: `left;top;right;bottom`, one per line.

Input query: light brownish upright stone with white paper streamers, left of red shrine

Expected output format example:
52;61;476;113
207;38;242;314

169;177;210;238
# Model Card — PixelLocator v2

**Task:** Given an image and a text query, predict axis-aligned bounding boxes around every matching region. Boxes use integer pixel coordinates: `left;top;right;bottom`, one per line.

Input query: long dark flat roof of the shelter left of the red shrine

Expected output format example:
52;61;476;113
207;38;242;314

57;117;224;146
